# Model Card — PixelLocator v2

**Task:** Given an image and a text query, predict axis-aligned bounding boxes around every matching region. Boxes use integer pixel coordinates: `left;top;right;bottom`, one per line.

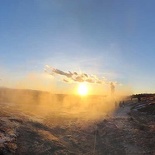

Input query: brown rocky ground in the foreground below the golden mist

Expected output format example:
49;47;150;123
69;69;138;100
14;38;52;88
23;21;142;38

0;102;155;155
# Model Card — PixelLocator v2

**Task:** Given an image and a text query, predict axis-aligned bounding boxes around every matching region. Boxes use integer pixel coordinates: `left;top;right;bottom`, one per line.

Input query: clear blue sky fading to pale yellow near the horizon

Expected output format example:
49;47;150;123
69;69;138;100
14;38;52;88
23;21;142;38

0;0;155;93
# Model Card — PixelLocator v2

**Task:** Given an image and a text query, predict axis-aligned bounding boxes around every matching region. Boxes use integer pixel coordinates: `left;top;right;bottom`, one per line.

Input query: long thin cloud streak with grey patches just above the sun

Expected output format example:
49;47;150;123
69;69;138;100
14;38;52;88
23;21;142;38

45;65;107;84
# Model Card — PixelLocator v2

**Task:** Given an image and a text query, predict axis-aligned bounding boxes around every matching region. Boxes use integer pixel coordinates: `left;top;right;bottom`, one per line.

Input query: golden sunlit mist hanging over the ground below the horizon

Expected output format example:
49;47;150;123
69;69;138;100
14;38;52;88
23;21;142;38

0;88;126;123
